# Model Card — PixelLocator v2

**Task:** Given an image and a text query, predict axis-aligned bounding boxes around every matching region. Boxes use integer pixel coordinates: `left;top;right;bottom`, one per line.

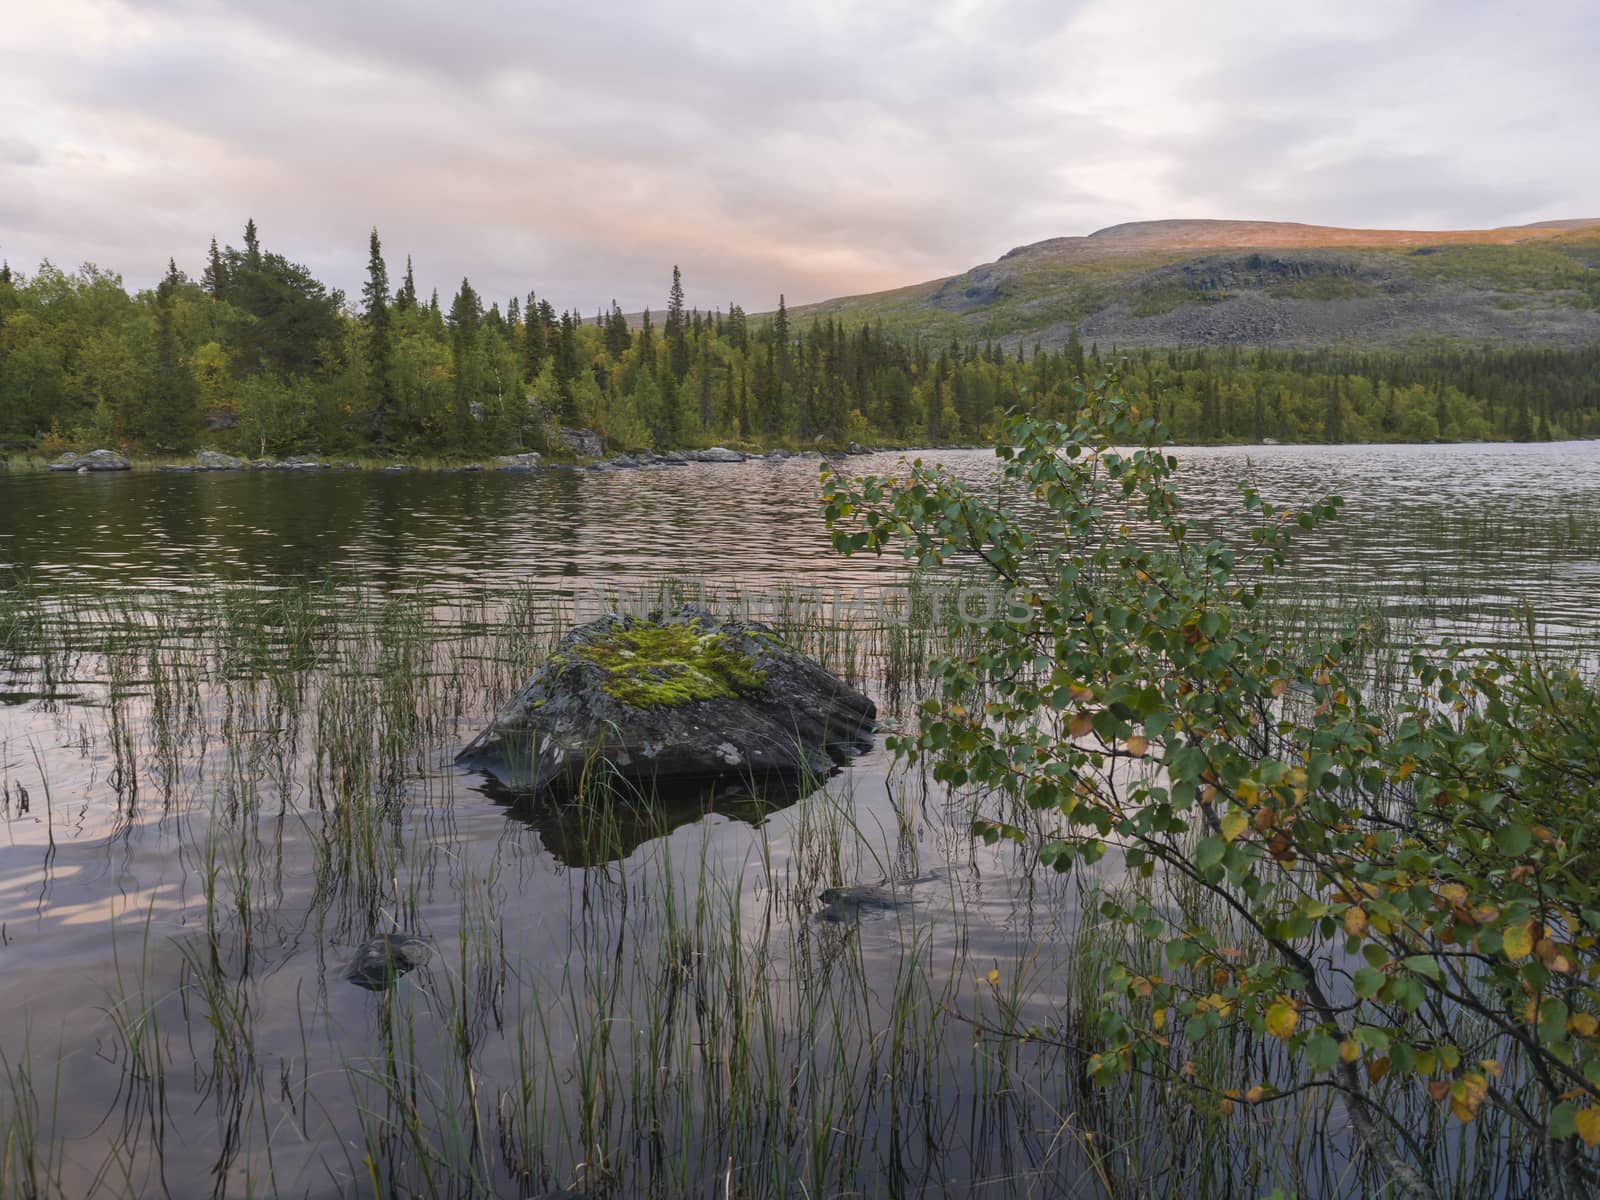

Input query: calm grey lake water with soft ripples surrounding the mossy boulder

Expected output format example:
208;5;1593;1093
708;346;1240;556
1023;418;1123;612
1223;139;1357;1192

0;443;1600;1197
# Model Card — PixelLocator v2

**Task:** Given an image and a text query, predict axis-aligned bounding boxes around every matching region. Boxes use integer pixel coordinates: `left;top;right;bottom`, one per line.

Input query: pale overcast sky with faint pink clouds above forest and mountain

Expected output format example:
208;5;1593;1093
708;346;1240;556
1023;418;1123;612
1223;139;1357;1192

0;0;1600;312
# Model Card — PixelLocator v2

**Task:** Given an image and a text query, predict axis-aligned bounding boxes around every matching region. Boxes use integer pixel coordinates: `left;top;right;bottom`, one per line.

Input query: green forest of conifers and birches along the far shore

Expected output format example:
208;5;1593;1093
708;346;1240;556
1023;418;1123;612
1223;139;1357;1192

0;221;1600;459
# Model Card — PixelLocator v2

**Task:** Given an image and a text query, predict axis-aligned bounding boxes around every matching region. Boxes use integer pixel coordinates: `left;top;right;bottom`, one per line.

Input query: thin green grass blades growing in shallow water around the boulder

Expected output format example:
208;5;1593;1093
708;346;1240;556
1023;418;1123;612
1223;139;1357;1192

0;569;1580;1200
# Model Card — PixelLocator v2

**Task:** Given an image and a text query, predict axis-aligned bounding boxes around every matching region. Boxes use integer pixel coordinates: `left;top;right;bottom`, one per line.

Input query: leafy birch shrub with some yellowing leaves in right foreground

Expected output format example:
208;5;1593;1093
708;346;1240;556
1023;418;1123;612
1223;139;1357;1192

824;379;1600;1195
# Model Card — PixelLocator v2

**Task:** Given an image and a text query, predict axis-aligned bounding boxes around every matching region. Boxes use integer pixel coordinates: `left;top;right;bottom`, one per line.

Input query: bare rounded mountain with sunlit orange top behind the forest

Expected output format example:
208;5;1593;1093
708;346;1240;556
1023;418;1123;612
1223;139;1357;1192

790;218;1600;347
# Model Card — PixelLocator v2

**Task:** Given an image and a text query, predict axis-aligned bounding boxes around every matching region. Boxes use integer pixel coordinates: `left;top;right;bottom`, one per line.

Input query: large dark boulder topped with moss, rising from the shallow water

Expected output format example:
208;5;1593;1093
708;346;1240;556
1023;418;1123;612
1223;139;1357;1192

456;606;877;792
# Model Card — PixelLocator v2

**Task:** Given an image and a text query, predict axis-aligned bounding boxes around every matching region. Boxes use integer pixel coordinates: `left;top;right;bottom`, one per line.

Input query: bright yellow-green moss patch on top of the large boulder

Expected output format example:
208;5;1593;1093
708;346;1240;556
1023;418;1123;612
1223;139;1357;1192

578;622;766;709
